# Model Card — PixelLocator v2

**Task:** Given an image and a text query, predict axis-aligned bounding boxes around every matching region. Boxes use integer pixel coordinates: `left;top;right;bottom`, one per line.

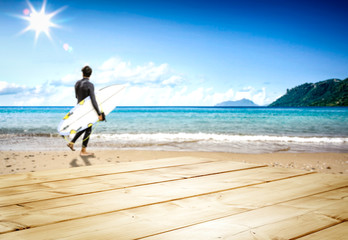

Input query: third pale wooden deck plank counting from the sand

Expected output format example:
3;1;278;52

0;165;310;232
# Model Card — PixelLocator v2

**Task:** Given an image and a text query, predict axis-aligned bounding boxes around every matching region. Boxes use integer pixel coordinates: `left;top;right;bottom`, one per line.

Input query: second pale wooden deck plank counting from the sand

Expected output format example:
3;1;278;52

0;161;266;206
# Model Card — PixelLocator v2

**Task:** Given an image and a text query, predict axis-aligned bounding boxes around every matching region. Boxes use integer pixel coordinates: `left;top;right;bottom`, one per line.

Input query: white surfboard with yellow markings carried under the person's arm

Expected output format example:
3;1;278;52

57;85;125;136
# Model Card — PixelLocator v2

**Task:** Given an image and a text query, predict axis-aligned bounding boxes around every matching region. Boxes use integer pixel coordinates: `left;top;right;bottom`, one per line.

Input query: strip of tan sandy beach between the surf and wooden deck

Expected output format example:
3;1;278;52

0;150;348;175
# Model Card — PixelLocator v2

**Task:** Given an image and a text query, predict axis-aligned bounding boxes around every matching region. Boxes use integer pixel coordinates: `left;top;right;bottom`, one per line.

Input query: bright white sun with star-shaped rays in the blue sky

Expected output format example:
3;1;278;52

21;0;65;42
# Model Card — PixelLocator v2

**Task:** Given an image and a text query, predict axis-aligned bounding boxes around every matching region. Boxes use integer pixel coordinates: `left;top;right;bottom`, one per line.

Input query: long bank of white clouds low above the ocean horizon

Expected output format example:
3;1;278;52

0;58;271;106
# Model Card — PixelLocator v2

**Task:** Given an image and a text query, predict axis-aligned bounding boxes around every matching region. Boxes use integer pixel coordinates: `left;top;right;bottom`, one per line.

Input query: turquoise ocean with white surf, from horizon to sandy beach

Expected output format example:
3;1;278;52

0;107;348;153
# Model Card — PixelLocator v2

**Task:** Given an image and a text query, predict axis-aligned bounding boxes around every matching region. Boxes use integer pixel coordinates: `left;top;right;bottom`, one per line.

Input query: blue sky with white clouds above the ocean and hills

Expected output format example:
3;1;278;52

0;0;348;106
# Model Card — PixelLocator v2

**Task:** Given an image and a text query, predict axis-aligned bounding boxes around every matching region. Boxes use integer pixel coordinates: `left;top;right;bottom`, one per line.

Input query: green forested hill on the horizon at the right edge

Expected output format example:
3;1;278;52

269;78;348;107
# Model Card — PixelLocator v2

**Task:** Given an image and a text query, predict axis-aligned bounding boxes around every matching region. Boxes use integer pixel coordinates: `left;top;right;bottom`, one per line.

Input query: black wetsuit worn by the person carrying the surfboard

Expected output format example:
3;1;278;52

71;78;101;148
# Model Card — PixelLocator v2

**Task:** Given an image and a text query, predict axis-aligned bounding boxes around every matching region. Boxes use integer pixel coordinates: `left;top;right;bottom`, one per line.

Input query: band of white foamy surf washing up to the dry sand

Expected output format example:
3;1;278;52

0;133;348;154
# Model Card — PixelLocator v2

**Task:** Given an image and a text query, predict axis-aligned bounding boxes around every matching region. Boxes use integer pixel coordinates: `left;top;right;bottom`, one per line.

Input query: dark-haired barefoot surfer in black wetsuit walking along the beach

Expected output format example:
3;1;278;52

68;66;104;156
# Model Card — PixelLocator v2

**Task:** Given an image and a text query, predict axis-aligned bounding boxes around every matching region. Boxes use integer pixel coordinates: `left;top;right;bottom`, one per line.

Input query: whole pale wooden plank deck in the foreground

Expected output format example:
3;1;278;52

0;157;348;240
